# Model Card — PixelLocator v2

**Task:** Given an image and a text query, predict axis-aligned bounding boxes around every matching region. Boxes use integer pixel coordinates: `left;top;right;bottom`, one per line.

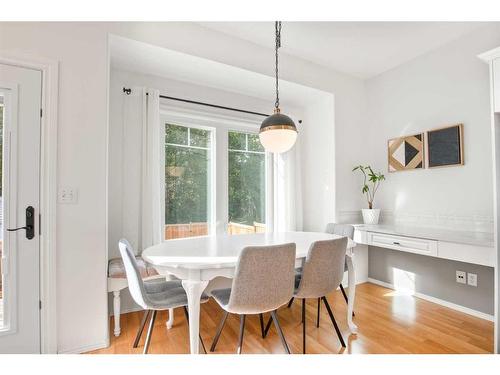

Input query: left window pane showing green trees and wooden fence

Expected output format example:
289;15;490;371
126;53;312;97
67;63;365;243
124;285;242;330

165;125;211;239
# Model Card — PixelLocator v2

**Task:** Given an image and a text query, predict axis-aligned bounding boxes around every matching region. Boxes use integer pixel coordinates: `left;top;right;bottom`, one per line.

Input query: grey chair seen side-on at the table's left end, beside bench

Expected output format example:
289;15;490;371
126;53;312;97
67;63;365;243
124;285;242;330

118;239;208;354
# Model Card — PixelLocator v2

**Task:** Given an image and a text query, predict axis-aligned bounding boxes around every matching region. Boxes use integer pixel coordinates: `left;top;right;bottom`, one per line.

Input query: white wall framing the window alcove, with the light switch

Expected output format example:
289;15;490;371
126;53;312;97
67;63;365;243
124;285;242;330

0;22;364;352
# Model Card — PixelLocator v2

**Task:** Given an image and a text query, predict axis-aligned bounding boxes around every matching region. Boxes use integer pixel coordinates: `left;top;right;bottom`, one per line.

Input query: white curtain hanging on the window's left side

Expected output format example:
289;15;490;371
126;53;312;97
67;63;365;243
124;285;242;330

121;87;161;252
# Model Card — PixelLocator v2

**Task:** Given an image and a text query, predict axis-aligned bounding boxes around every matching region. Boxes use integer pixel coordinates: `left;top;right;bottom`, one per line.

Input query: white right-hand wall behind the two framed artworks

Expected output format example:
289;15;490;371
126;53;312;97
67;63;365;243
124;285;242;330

366;25;500;231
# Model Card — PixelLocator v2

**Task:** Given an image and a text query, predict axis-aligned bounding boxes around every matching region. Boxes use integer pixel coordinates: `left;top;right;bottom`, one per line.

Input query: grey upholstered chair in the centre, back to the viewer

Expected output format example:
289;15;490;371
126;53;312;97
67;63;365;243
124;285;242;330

210;243;295;354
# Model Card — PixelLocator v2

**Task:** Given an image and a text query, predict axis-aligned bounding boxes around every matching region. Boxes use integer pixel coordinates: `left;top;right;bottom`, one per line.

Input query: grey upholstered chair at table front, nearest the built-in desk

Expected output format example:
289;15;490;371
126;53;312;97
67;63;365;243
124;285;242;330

264;237;347;353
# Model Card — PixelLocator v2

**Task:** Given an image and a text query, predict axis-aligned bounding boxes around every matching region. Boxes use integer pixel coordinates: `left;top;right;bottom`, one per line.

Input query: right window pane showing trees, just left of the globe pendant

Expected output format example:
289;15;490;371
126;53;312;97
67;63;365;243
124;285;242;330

228;132;266;234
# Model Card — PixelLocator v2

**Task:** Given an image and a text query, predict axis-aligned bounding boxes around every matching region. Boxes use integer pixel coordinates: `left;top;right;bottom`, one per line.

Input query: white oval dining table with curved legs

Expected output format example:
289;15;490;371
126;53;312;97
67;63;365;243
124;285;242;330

142;232;357;354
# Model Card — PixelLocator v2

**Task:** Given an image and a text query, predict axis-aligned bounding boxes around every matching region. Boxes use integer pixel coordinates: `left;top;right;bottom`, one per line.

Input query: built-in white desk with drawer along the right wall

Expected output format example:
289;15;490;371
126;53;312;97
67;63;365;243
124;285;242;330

354;224;496;267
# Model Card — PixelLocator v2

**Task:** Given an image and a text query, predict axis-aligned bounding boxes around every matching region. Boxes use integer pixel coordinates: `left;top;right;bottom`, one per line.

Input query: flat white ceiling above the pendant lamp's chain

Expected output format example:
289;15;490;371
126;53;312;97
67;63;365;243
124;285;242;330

200;22;486;79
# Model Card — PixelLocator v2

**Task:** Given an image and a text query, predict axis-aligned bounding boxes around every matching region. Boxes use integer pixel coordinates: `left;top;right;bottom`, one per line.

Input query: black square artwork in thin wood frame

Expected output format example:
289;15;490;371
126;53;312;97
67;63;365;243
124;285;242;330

427;124;464;168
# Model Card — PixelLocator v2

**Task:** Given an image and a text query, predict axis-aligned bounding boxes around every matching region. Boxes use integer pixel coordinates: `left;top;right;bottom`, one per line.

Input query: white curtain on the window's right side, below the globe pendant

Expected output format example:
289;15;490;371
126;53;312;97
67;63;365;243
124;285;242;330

273;142;302;232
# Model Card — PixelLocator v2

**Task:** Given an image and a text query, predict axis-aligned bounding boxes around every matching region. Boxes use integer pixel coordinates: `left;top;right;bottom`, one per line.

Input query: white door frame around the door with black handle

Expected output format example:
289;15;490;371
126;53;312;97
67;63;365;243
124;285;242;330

0;51;59;354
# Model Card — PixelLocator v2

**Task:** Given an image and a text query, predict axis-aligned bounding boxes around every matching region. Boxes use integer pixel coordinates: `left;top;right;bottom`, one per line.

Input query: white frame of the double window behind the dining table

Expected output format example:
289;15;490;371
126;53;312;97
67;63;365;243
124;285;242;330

160;103;274;241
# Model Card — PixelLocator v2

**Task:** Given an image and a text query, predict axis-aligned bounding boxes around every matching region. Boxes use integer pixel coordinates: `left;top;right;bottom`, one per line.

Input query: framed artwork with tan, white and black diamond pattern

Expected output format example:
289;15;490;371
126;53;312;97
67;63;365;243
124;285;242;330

387;133;424;172
